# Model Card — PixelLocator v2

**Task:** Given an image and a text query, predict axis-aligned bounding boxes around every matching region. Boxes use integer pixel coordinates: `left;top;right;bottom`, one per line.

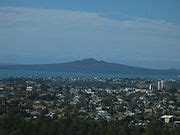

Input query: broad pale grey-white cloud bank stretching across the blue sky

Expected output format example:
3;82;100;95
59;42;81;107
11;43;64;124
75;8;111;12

0;7;180;66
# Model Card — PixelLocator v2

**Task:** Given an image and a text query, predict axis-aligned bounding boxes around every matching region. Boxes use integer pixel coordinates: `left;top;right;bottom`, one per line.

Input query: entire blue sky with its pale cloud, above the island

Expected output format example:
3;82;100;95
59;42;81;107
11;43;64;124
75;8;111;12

0;0;180;69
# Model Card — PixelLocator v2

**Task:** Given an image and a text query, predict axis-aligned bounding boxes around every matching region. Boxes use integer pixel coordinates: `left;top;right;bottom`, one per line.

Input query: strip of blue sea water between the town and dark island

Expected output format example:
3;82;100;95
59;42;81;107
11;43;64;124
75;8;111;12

0;69;180;79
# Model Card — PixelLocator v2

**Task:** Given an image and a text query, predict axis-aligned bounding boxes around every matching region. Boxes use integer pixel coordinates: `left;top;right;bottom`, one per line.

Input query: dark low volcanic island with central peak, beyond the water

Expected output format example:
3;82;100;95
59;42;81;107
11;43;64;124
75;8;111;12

0;58;180;75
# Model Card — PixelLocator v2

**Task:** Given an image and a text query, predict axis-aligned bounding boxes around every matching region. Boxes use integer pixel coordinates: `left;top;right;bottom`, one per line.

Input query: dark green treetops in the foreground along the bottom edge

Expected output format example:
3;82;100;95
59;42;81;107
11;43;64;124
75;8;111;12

0;110;180;135
